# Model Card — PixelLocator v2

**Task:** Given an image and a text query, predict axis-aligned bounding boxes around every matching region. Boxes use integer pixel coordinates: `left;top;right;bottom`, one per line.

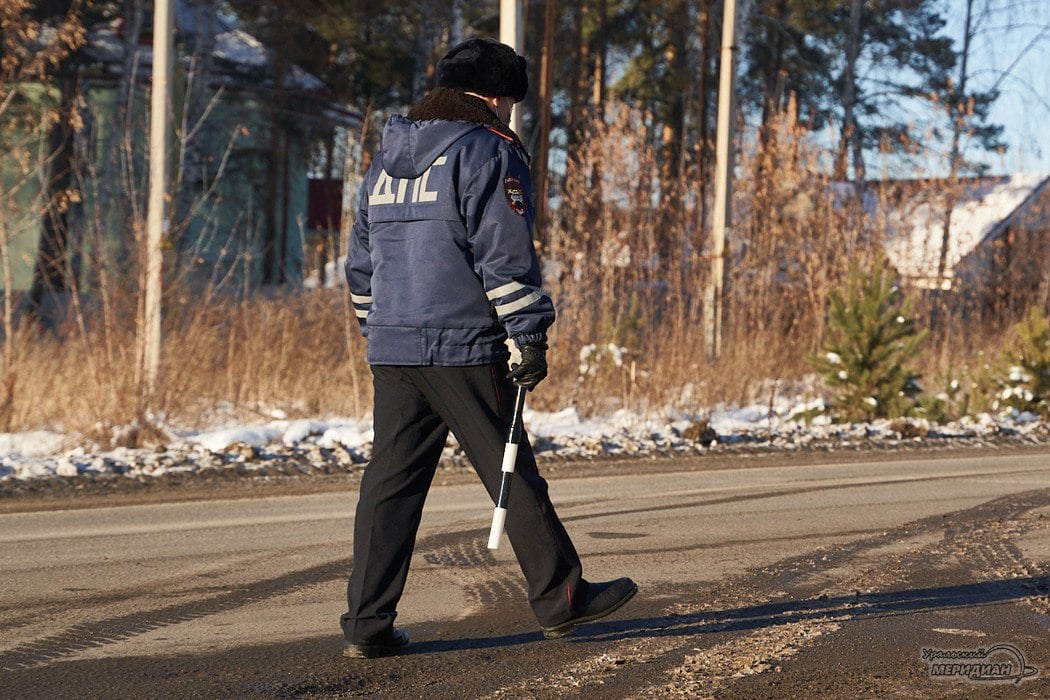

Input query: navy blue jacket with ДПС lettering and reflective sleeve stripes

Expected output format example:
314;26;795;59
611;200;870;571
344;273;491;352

345;110;554;366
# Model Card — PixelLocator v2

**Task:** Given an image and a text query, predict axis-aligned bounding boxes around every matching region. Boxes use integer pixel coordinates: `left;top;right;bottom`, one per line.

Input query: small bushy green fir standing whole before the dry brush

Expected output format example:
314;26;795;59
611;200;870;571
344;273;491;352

809;261;927;422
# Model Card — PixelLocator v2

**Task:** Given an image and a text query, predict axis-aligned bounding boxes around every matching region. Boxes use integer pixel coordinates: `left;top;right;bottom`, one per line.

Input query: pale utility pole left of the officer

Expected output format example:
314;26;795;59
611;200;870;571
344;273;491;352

140;0;173;398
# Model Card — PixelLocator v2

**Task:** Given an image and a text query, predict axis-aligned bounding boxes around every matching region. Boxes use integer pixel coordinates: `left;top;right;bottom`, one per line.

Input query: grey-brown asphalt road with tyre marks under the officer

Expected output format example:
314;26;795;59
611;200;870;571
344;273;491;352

0;449;1050;698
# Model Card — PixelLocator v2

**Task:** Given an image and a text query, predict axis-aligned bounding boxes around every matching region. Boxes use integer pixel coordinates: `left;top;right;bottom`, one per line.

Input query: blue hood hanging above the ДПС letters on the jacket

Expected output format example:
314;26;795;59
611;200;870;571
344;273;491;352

379;114;482;179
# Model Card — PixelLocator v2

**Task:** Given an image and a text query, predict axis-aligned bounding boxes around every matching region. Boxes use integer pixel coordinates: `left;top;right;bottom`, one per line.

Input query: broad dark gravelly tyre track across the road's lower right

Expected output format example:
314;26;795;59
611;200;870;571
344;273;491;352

478;490;1050;699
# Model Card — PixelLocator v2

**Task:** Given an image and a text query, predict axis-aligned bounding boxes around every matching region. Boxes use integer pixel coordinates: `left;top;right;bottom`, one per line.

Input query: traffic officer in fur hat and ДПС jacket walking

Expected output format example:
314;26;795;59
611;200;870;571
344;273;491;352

341;39;637;658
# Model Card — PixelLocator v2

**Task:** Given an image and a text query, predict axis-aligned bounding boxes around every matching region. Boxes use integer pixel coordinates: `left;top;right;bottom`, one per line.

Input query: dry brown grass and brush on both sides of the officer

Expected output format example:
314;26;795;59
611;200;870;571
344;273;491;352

0;99;1045;442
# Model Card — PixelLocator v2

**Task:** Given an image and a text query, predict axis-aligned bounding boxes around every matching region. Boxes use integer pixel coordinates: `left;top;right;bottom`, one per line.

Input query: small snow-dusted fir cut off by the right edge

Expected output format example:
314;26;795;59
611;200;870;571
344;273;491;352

996;306;1050;419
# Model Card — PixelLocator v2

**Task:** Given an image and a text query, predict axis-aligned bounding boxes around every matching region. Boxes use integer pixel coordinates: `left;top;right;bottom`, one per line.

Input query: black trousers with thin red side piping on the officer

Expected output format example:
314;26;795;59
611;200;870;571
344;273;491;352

341;364;586;643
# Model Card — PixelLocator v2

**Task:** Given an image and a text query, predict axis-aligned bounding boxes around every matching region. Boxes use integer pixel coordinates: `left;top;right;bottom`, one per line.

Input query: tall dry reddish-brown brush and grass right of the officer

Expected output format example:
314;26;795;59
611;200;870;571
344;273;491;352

533;98;1046;412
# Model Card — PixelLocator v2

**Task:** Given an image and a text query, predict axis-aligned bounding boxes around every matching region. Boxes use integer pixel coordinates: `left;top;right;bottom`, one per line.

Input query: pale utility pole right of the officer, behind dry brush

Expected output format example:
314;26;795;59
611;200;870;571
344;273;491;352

701;0;737;360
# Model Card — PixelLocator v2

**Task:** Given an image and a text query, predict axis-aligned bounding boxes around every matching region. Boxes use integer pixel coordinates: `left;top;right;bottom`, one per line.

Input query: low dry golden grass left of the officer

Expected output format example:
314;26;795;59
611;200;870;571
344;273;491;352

0;292;371;442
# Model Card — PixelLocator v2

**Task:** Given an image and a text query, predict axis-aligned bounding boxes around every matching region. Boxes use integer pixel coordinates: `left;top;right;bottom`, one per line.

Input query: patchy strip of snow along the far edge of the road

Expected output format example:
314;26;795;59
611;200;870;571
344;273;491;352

0;402;1050;494
